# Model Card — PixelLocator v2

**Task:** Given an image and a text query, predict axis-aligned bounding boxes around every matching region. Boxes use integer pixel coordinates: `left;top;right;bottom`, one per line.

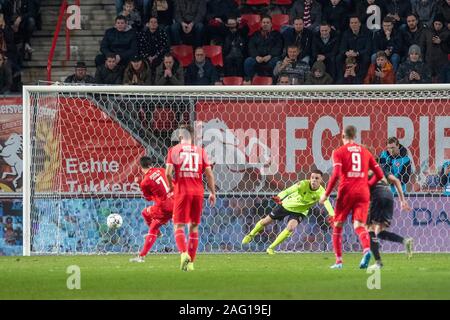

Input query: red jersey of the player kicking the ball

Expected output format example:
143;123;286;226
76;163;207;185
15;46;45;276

139;168;169;204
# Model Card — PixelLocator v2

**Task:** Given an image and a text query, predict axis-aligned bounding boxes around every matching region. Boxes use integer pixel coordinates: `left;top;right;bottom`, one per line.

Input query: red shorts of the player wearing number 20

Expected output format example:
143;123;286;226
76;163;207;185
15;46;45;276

173;194;203;224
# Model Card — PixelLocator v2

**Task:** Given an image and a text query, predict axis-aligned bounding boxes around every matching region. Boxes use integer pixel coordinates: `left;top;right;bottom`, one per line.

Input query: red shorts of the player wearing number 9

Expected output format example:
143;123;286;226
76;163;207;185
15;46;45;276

333;196;370;223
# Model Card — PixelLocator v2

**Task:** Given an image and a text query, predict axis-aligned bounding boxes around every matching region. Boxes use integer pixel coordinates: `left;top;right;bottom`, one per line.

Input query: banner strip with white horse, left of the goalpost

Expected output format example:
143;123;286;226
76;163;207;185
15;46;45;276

0;97;22;192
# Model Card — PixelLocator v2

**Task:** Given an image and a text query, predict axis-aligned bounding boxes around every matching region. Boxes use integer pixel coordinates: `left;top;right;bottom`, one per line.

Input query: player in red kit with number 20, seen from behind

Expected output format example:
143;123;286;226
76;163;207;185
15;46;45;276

166;125;216;271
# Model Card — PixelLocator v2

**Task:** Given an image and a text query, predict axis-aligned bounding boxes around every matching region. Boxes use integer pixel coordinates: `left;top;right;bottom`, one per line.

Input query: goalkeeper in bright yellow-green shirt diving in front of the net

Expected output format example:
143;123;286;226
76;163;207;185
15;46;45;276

242;170;334;254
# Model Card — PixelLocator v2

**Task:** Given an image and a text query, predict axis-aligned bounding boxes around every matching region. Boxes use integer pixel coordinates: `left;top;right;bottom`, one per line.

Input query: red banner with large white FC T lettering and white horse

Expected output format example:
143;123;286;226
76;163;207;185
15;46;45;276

196;99;450;191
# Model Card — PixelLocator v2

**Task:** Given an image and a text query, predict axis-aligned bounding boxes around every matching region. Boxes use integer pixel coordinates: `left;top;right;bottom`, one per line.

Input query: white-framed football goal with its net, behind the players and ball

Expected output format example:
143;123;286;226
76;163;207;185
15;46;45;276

23;85;450;255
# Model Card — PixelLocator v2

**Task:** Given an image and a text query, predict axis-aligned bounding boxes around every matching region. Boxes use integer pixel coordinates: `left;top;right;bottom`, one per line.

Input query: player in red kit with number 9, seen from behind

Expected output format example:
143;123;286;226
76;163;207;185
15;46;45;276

319;126;383;269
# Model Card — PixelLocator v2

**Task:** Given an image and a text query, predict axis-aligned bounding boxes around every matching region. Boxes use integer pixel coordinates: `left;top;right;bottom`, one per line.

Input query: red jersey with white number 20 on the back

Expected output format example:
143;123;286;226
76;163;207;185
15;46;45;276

166;144;211;196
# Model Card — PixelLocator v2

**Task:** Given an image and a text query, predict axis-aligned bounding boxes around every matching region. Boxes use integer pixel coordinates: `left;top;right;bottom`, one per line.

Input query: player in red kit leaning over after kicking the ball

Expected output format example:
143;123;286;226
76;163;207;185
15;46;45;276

130;157;173;262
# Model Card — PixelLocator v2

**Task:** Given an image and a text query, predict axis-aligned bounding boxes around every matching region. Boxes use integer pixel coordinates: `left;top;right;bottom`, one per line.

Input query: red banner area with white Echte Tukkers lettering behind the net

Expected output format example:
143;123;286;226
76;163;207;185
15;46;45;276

46;98;145;194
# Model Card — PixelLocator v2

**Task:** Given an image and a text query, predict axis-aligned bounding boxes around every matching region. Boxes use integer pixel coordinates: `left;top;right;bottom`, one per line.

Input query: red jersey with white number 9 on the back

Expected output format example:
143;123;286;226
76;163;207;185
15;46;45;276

326;143;381;197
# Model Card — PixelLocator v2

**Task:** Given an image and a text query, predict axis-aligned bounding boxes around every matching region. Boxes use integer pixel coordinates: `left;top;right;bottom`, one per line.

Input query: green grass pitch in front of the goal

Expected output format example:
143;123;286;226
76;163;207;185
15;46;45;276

0;253;450;300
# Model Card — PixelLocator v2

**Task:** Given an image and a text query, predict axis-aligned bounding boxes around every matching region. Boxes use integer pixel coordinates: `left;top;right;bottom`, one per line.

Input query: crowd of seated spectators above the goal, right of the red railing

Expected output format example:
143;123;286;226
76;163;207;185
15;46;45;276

67;0;450;85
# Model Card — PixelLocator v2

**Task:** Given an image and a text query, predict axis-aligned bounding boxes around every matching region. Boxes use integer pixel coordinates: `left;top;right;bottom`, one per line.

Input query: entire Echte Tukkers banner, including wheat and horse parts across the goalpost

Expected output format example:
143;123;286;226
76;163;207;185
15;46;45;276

0;97;145;194
